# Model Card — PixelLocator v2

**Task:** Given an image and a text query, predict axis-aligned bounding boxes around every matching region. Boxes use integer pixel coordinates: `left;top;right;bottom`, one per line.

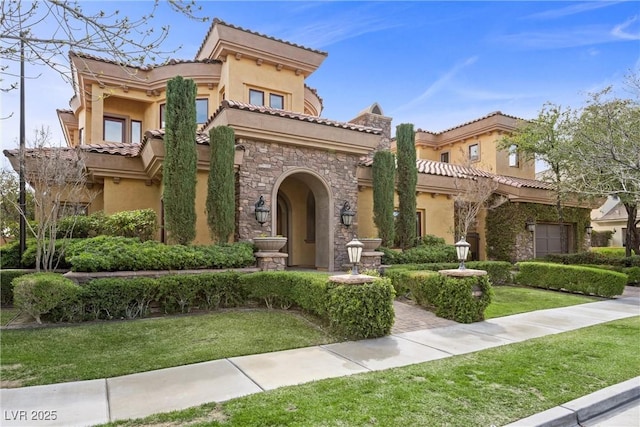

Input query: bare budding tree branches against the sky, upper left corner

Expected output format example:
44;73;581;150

0;0;208;97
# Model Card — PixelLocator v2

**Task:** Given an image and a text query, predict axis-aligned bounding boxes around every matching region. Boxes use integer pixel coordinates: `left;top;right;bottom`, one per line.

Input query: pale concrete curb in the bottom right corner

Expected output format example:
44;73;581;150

505;377;640;427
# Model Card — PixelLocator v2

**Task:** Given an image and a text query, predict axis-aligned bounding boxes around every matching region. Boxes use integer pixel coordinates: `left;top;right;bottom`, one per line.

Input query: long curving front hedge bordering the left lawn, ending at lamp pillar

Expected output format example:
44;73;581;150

13;272;395;339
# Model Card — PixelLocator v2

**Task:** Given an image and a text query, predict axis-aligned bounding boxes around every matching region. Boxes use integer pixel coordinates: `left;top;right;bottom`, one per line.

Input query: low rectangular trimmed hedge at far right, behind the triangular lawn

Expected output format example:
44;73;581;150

515;262;627;297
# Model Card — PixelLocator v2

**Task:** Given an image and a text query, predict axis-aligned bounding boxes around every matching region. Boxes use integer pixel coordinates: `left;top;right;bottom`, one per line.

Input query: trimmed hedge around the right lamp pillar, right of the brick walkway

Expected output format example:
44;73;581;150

397;270;493;323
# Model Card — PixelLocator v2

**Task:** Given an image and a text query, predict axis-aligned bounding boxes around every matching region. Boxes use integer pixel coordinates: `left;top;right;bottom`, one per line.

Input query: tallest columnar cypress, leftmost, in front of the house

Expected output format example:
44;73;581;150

162;76;198;245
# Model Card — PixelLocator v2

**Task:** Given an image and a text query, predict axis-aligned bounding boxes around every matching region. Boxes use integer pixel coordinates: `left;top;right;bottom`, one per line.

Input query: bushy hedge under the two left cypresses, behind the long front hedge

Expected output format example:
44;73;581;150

67;236;255;272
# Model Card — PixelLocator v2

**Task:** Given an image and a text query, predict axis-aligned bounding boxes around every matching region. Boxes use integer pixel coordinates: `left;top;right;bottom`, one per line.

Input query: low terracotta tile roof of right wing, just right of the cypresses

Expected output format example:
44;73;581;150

360;158;552;190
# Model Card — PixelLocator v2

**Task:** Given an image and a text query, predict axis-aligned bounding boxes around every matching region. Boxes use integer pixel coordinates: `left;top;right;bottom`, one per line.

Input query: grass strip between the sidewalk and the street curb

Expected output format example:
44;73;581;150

101;317;640;427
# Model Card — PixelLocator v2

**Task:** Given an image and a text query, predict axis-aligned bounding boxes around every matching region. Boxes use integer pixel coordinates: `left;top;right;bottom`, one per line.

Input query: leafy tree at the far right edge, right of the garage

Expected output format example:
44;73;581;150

567;88;640;256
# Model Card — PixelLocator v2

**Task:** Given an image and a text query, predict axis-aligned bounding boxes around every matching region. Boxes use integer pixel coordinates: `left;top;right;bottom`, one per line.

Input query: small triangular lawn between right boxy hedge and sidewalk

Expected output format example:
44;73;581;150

484;286;601;319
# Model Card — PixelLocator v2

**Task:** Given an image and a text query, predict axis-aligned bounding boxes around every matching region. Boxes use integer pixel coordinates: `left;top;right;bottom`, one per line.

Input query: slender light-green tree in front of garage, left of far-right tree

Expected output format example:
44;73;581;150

498;103;574;252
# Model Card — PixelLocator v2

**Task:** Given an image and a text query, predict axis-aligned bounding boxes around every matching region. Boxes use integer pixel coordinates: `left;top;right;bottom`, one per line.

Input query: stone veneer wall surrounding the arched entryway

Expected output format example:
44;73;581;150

237;139;360;270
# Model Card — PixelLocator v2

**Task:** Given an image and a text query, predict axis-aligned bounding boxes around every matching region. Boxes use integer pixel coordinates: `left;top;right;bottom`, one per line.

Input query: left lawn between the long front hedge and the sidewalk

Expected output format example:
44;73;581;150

0;310;335;387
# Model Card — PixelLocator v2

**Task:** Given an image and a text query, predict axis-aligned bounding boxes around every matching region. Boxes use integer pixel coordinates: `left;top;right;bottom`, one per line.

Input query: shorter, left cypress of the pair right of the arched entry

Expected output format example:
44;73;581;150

373;151;396;247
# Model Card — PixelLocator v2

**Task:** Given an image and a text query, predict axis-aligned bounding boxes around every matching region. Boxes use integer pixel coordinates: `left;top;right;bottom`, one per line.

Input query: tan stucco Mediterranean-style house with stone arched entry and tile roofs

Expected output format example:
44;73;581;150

5;19;589;271
